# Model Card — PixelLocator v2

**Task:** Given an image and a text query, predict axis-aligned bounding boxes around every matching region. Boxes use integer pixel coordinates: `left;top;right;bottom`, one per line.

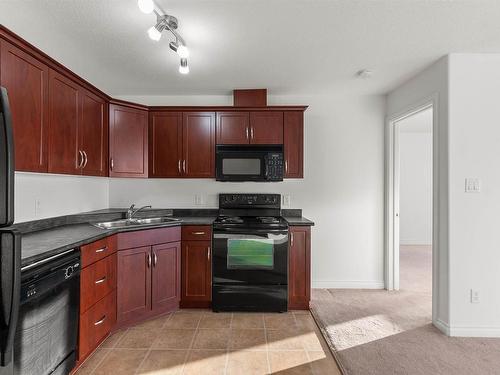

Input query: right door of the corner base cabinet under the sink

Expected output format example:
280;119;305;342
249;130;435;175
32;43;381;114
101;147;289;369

151;242;181;311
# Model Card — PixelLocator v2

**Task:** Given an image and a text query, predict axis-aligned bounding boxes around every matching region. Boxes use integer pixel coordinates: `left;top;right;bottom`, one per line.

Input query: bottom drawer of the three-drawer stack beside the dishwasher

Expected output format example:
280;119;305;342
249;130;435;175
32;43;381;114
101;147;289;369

78;291;116;361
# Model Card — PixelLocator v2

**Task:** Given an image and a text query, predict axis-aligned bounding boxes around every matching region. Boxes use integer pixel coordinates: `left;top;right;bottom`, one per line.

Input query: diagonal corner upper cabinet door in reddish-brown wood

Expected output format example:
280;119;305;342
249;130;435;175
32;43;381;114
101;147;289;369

109;104;148;177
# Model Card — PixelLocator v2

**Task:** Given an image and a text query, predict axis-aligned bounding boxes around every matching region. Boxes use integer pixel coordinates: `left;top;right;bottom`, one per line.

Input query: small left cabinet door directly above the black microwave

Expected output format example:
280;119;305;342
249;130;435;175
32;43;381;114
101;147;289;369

217;112;250;145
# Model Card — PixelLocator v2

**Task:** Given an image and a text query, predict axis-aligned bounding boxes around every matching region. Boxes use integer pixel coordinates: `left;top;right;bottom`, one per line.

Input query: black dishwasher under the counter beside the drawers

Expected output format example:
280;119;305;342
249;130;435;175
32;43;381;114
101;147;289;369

14;250;80;375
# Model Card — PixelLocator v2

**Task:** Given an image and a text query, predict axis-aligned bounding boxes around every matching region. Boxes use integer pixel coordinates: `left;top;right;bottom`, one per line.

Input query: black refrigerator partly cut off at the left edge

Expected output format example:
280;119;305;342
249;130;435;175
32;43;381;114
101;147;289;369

0;87;21;375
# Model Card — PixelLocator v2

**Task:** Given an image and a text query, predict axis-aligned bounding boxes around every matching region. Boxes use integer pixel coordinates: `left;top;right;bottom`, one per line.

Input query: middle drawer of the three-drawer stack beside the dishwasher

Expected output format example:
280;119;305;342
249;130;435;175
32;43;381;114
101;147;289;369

80;253;116;313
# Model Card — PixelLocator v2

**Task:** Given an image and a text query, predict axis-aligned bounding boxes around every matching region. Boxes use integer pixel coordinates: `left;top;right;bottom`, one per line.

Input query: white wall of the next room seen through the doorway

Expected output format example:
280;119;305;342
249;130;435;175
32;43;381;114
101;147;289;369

398;119;432;245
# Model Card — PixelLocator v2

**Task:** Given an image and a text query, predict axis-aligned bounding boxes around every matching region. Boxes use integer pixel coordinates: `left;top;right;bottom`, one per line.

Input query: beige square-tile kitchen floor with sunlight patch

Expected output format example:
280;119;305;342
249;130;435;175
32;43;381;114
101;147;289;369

76;310;340;375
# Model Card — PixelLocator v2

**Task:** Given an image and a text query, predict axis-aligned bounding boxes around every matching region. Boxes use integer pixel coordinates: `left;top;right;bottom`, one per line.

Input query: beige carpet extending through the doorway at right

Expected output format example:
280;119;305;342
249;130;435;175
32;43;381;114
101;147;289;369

311;246;500;375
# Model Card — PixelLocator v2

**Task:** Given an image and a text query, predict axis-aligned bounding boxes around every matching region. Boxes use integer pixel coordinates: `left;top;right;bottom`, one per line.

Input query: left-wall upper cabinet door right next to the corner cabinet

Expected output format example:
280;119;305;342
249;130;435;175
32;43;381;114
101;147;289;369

78;89;108;176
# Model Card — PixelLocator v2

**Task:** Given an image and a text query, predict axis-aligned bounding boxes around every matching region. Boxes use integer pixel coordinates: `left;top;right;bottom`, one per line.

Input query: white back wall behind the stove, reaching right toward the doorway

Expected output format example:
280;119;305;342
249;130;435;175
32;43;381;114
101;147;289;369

114;94;385;288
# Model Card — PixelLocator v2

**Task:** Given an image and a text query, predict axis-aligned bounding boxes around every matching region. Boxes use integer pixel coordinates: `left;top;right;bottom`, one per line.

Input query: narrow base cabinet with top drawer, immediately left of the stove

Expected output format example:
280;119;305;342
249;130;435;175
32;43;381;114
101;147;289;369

181;226;212;308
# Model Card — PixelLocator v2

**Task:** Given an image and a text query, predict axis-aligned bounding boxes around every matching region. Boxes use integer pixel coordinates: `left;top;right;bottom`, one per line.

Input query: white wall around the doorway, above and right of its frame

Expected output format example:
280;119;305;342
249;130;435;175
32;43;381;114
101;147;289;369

387;56;450;332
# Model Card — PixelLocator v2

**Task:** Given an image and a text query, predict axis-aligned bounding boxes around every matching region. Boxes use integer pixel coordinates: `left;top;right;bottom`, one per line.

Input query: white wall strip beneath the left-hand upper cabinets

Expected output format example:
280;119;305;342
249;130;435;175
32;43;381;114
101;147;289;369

14;172;109;223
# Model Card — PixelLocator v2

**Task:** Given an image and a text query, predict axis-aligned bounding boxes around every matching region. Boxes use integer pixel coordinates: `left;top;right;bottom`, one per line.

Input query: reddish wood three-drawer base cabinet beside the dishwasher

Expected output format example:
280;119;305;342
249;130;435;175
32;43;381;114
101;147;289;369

78;236;117;363
